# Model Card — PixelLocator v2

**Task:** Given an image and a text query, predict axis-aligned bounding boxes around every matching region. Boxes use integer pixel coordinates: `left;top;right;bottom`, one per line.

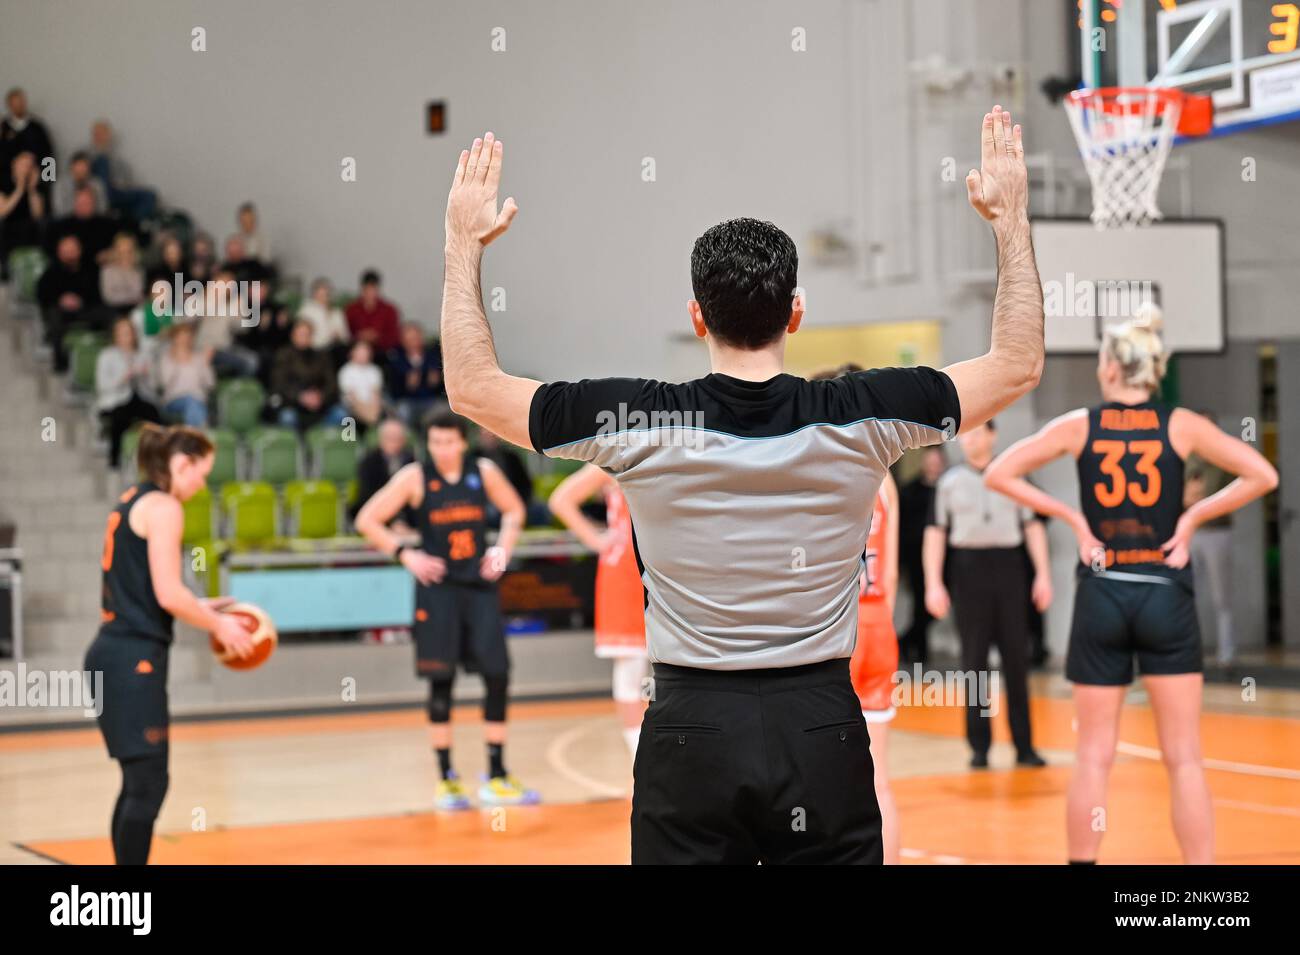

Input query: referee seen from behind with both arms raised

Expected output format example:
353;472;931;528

442;107;1043;864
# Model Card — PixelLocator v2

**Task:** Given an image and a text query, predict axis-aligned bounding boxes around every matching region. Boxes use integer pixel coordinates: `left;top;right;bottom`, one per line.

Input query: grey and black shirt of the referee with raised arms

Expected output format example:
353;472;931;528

529;368;961;670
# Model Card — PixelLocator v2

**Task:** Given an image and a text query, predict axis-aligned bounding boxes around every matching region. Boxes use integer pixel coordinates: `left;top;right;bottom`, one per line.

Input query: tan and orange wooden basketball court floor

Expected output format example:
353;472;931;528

0;681;1300;864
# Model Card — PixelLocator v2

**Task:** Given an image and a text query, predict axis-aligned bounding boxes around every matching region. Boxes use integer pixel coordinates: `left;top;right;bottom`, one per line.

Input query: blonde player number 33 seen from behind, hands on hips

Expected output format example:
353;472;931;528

984;305;1278;863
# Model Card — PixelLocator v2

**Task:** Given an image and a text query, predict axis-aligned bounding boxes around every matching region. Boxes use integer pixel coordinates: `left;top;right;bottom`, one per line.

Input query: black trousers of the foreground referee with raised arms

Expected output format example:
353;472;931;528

632;659;881;865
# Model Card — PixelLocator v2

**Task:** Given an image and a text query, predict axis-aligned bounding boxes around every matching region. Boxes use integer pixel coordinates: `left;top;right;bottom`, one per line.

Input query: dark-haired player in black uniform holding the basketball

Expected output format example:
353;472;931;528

86;425;254;865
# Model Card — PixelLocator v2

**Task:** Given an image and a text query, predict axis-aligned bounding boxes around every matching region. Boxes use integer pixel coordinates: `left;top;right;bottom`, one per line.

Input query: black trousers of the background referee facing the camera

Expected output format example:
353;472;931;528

944;547;1034;754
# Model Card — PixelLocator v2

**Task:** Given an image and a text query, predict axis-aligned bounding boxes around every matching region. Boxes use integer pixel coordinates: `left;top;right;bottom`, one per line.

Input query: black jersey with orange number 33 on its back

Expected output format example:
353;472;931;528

1078;401;1183;573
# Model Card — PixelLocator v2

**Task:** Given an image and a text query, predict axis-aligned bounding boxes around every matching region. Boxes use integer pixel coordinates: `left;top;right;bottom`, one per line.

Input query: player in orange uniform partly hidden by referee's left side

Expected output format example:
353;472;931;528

547;464;650;759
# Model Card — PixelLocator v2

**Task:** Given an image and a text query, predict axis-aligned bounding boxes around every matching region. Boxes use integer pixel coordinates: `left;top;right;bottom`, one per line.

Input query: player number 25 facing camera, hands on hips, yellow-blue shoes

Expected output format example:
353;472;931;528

356;412;540;811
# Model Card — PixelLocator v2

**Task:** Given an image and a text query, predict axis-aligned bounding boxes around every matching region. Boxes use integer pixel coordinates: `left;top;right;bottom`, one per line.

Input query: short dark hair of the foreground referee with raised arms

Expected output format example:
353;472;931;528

690;218;800;350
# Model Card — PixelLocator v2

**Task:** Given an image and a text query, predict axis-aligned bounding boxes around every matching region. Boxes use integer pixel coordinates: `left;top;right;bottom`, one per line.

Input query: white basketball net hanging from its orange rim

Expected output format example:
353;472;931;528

1065;87;1182;229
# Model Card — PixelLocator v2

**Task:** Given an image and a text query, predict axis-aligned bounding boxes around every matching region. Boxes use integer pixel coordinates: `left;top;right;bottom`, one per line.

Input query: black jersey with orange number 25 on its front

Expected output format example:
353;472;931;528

419;455;488;586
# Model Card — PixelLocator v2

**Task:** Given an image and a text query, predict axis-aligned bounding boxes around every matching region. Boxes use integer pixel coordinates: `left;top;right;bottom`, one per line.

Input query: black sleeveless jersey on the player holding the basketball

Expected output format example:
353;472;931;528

99;481;172;643
